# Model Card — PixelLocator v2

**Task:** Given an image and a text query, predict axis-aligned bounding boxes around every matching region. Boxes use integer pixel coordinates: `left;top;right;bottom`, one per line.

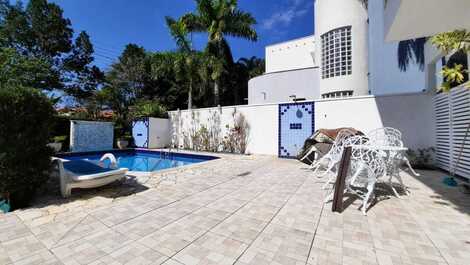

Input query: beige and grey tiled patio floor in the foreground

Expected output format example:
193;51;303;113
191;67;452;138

0;156;470;265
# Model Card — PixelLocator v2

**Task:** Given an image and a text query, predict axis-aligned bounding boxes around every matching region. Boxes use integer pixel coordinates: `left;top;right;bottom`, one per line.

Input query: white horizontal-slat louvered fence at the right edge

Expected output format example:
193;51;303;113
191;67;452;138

434;87;470;178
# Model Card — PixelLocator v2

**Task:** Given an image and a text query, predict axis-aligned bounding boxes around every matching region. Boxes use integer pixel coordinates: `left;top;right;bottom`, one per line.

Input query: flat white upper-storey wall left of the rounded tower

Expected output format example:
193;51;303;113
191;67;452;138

265;36;316;73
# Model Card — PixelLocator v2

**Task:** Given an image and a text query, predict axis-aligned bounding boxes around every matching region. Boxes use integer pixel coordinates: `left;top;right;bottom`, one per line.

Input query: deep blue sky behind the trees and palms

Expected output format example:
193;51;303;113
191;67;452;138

50;0;314;70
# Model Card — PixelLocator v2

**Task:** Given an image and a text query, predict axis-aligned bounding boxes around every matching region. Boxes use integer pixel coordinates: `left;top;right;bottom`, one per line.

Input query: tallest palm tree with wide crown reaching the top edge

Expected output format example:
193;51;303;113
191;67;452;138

182;0;258;105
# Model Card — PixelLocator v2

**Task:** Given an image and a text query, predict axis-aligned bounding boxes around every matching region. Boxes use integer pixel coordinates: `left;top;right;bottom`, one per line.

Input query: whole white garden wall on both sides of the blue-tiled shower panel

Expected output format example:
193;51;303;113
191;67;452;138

170;94;435;155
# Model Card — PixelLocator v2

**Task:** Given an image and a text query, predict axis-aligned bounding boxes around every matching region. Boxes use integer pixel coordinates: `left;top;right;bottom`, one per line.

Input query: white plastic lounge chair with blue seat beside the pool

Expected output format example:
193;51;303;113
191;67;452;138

53;154;128;198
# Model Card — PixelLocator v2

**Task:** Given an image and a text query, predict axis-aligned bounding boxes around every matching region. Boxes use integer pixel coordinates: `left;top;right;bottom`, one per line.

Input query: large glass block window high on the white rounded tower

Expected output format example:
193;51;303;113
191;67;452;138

321;26;352;79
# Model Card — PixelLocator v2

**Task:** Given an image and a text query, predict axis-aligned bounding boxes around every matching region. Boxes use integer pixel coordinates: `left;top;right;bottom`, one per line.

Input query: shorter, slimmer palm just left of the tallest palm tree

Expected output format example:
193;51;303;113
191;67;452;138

165;17;205;109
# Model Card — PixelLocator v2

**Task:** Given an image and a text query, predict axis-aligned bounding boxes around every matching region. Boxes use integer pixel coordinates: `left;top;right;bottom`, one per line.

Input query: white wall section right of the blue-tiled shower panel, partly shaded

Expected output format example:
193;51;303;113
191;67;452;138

315;94;435;149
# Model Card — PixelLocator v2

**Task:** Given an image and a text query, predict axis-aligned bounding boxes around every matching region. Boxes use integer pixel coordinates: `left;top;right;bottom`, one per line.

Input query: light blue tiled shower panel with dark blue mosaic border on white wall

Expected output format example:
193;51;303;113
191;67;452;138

279;102;315;158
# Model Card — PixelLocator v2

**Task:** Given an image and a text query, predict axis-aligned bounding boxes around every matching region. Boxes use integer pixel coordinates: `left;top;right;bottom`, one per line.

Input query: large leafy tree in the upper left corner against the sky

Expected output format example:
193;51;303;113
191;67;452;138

0;0;102;99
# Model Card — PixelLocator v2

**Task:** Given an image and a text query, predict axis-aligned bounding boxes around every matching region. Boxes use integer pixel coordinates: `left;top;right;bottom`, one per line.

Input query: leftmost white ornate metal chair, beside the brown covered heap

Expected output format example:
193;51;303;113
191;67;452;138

311;129;354;179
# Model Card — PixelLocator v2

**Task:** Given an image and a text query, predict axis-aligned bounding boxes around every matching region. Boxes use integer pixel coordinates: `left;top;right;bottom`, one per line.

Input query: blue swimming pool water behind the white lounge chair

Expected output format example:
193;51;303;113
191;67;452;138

57;149;218;172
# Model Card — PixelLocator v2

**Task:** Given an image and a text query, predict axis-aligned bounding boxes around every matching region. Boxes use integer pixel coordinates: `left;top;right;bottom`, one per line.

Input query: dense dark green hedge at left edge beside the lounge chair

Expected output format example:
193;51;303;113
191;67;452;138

0;87;54;208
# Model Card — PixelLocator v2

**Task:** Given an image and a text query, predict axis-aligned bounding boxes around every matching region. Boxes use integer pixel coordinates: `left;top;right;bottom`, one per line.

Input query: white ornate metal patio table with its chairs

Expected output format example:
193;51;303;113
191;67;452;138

311;127;419;215
